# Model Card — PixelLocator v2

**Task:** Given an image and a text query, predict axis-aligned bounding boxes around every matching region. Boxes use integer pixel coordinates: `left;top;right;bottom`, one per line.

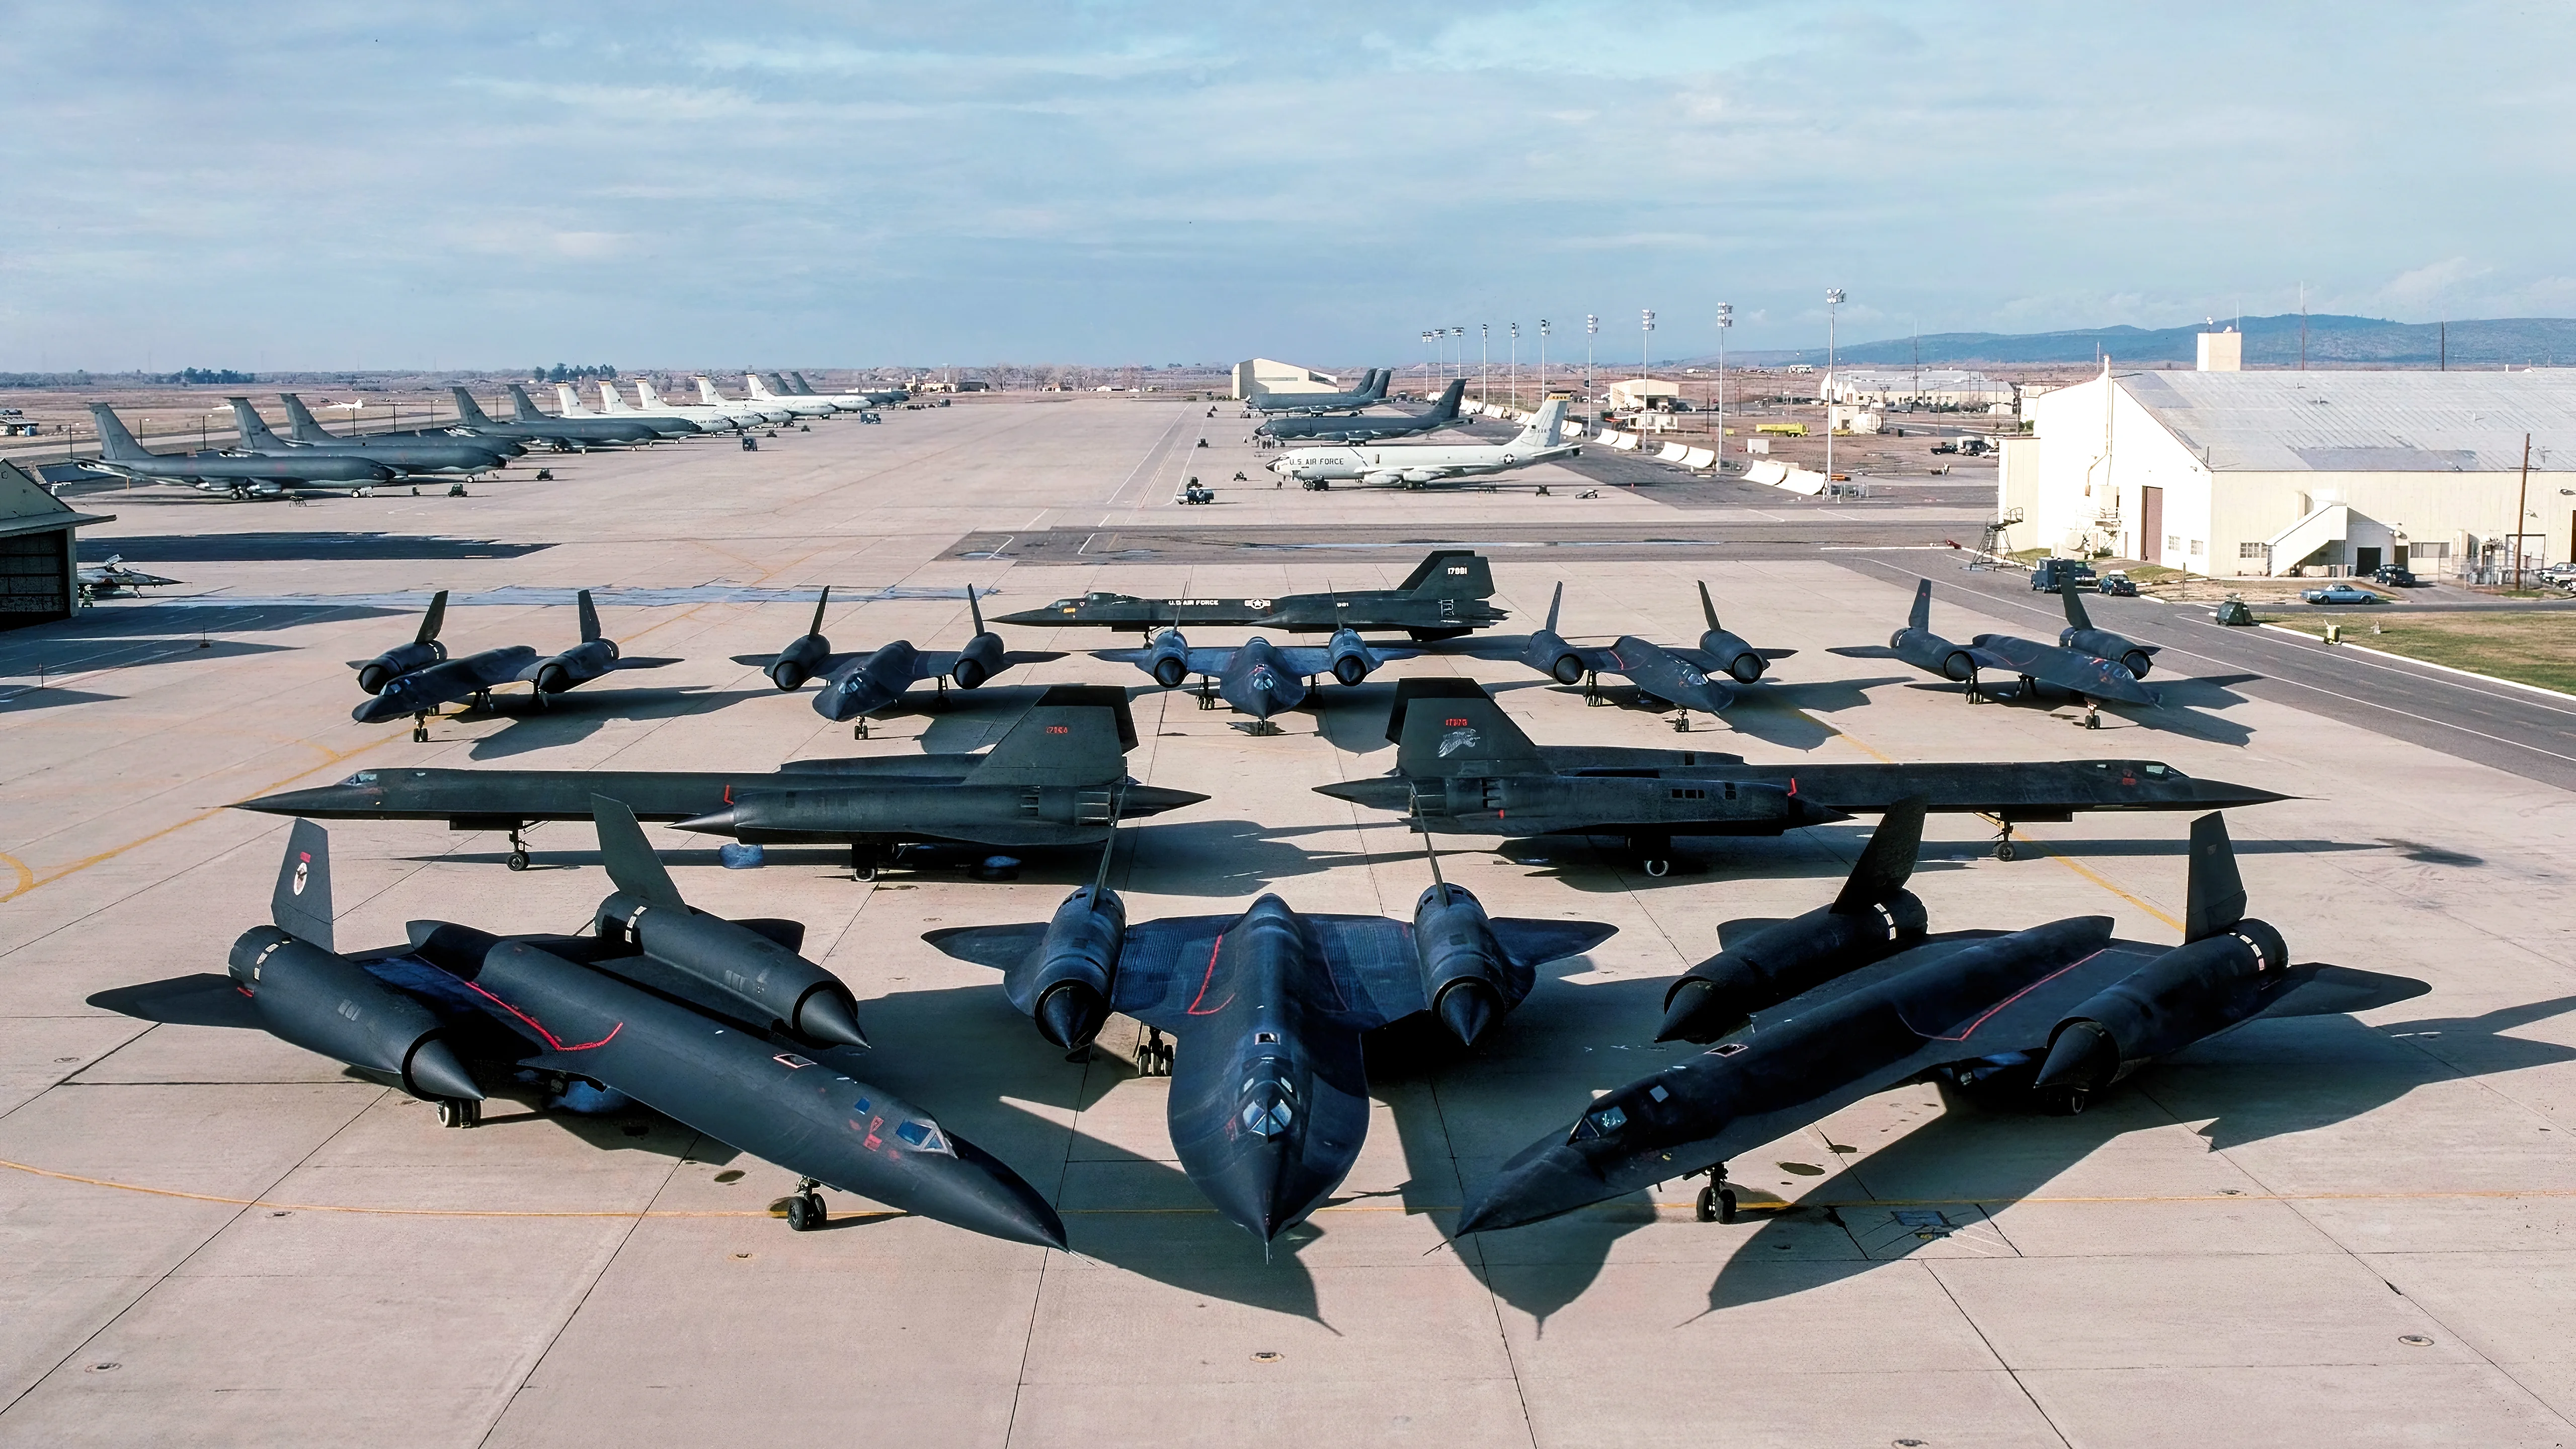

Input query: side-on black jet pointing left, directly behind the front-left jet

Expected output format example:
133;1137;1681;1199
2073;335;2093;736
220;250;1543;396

237;683;1208;879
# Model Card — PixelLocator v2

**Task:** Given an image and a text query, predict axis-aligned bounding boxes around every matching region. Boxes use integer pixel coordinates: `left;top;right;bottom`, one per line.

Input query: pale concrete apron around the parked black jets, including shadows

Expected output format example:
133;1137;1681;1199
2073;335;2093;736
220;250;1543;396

0;397;2576;1446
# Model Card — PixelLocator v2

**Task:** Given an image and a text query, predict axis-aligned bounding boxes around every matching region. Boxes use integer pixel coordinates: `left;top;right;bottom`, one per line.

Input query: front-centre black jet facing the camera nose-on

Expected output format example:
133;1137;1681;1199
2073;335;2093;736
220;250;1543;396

922;825;1618;1253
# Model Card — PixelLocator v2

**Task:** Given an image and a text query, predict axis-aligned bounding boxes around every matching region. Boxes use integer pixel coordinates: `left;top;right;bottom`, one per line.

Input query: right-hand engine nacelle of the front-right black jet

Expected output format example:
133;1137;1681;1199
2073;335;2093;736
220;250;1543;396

2033;920;2290;1111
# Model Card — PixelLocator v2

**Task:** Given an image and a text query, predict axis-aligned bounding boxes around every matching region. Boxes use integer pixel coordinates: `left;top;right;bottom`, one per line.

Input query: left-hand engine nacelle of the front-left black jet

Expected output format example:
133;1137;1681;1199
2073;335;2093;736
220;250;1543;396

232;926;481;1101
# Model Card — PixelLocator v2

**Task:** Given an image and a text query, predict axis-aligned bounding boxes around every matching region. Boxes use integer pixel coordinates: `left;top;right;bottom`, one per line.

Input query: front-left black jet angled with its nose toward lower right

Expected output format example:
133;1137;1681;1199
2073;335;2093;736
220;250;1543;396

90;799;1064;1248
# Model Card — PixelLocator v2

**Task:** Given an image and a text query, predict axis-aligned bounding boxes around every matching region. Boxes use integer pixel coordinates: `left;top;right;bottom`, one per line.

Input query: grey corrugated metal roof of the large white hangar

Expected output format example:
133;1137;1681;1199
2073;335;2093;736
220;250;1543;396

2112;369;2576;472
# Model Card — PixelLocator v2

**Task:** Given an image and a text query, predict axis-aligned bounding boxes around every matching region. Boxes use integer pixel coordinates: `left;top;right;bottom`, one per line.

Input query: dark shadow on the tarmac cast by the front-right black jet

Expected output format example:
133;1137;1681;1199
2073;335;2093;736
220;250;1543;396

1471;980;2576;1320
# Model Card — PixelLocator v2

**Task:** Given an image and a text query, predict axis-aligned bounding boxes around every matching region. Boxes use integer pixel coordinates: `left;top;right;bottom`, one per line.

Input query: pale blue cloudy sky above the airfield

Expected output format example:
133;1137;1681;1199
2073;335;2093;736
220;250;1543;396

0;0;2576;371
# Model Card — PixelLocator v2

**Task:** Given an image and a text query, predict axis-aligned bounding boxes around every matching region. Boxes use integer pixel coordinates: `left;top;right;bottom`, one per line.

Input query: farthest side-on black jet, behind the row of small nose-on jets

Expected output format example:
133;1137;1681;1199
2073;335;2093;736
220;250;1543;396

994;549;1509;639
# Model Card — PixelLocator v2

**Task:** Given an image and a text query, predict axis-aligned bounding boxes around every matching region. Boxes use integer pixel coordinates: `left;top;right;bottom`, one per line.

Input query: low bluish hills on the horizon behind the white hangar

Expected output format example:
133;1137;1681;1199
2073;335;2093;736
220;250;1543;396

1729;312;2576;366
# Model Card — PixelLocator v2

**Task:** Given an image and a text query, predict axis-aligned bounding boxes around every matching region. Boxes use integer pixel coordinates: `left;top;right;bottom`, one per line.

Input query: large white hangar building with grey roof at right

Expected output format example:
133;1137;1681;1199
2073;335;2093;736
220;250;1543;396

1996;335;2576;578
